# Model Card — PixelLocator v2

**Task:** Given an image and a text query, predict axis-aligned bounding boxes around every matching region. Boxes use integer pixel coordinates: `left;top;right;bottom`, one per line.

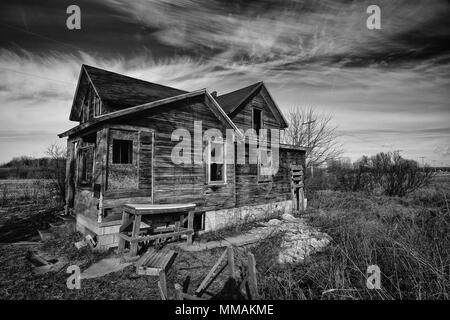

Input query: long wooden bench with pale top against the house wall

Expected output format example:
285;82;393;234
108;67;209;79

119;203;196;259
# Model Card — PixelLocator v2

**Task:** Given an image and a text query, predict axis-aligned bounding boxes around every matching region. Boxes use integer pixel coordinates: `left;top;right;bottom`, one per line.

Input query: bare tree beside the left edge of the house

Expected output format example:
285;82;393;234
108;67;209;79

45;142;66;201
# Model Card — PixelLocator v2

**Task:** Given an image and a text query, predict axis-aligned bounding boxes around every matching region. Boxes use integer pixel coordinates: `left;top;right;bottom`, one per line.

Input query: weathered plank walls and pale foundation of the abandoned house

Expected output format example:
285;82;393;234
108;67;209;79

67;94;304;245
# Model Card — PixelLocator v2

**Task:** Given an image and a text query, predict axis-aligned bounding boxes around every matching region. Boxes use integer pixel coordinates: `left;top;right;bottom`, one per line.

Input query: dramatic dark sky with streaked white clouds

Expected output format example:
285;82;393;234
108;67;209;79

0;0;450;165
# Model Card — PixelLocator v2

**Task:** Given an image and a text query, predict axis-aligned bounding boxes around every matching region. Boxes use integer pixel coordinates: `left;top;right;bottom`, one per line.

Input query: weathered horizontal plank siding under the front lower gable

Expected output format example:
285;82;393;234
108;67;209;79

110;97;235;211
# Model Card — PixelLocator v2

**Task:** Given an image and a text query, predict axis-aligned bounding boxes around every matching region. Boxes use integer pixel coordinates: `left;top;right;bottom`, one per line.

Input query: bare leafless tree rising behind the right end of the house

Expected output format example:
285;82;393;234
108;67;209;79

283;107;343;167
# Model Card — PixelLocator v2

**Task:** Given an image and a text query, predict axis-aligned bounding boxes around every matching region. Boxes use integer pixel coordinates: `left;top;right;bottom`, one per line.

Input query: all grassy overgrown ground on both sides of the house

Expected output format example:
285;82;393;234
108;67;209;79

0;176;450;299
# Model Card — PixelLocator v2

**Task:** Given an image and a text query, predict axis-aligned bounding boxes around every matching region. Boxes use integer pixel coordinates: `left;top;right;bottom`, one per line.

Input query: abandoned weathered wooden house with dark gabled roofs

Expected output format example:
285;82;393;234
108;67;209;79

59;65;305;247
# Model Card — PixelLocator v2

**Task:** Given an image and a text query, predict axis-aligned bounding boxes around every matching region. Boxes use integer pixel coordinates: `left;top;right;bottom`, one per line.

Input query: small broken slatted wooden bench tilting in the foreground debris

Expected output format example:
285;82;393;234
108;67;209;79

135;248;177;300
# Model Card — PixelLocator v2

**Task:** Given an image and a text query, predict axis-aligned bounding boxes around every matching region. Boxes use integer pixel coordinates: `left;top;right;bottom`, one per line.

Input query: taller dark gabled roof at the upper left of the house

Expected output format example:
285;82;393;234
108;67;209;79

70;64;187;121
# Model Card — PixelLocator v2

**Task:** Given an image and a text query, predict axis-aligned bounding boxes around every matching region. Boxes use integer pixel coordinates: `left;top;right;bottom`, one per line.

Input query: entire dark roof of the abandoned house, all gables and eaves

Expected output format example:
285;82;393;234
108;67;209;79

59;64;287;137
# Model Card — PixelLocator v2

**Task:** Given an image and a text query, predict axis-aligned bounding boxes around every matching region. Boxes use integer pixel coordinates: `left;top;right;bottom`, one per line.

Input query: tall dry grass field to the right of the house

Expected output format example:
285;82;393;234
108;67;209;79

257;176;450;299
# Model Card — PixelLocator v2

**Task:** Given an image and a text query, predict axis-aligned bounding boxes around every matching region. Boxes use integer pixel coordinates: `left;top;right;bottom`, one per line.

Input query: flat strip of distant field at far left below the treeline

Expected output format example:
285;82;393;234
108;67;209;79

0;179;54;204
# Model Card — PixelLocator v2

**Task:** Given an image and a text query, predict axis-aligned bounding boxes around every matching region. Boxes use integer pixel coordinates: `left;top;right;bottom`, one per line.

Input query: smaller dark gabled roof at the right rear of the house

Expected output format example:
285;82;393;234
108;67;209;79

216;81;288;128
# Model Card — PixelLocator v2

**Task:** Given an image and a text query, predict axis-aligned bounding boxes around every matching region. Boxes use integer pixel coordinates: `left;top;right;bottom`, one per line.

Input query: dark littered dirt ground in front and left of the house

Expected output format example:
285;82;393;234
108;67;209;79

0;202;270;300
